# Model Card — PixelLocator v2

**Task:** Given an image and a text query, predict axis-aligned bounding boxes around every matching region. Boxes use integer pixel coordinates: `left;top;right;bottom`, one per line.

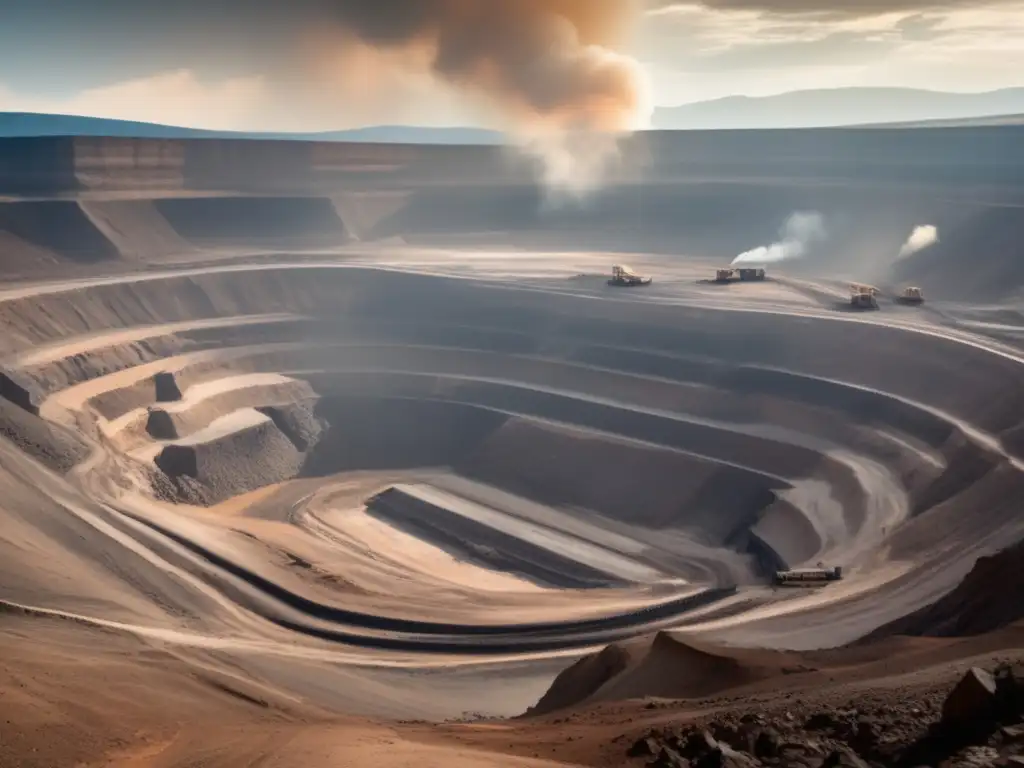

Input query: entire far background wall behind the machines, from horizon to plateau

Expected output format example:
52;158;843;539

0;126;1024;298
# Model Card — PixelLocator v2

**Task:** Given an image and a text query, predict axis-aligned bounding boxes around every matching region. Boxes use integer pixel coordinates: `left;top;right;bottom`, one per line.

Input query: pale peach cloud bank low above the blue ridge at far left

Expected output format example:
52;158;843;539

0;70;268;130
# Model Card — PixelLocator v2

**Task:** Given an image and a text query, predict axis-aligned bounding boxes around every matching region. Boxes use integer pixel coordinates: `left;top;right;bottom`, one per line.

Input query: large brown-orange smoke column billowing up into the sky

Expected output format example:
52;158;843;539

317;0;651;190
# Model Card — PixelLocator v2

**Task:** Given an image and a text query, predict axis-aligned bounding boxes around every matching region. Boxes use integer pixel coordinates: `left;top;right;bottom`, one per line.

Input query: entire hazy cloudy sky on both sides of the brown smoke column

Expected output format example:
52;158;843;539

0;0;1024;130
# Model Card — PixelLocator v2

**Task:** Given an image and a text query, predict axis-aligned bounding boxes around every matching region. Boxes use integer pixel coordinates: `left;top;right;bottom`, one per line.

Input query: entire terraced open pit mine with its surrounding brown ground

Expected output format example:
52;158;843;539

0;127;1024;766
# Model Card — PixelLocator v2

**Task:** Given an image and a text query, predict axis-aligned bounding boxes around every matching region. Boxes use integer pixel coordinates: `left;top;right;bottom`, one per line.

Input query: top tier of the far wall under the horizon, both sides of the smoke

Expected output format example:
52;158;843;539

0;126;1024;195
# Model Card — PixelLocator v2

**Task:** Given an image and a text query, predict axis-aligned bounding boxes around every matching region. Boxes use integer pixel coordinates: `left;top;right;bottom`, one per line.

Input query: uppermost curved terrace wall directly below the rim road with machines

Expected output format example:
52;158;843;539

8;268;1024;444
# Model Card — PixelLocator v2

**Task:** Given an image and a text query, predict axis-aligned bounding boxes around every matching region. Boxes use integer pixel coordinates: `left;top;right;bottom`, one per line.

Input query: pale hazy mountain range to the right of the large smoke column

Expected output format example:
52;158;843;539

653;88;1024;130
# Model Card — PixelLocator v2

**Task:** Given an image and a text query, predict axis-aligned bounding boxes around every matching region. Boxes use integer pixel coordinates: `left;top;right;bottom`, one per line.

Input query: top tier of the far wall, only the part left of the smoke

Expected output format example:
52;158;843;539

0;136;520;196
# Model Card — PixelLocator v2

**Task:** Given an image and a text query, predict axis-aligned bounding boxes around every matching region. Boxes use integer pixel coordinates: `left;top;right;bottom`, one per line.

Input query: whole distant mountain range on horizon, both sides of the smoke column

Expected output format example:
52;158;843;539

6;87;1024;144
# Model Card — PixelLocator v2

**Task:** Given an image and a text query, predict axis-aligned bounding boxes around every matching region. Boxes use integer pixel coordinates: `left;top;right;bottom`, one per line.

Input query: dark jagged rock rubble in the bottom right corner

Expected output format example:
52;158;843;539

626;664;1024;768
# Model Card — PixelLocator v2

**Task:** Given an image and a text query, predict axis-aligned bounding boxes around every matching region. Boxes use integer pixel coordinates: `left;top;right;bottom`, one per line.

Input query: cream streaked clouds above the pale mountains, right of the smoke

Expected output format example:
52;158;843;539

638;0;1024;106
